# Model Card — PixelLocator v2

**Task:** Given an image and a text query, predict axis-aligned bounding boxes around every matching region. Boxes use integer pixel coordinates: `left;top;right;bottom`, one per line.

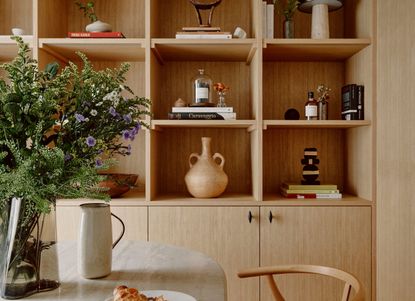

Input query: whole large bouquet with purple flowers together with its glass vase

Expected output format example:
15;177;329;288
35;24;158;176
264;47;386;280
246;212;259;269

0;36;150;299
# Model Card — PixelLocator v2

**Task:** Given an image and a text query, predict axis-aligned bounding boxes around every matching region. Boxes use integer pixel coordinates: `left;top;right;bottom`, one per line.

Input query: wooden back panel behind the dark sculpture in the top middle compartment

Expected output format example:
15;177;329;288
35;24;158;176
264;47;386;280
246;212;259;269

153;0;254;38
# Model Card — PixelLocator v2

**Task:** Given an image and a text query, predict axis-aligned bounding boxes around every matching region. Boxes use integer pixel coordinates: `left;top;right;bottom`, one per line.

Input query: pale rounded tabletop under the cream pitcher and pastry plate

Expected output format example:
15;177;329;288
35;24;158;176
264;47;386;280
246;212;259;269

1;241;226;301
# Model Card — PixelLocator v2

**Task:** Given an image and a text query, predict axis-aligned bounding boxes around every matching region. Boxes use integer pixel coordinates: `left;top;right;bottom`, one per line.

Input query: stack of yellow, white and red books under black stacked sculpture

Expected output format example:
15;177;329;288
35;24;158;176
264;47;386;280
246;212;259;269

281;183;342;199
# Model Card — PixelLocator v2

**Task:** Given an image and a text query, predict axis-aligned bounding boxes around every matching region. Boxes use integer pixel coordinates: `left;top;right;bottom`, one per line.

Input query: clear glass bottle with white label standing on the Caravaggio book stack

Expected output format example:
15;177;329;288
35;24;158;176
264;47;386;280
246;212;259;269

191;69;214;107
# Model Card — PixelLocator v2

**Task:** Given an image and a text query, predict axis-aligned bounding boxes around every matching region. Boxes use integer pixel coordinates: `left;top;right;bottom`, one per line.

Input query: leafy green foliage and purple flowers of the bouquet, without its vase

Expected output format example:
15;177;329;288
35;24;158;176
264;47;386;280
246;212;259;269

0;37;150;212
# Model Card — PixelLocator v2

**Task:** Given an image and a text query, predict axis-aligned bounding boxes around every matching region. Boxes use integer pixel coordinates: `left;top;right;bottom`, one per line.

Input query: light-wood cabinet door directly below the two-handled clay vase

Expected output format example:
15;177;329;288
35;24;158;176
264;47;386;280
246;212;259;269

149;207;259;301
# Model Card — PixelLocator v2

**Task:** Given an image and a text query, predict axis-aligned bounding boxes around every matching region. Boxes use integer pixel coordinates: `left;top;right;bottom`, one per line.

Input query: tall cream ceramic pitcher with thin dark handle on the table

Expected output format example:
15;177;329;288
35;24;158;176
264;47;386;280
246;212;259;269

78;203;125;279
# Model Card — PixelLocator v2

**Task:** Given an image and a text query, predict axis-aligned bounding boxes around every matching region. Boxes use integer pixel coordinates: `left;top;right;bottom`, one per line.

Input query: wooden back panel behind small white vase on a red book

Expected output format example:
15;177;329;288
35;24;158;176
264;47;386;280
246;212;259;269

39;0;145;38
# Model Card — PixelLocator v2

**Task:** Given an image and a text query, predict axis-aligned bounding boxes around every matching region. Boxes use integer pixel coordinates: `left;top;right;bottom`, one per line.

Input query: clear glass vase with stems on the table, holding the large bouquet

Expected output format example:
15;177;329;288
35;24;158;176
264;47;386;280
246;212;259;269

0;198;59;299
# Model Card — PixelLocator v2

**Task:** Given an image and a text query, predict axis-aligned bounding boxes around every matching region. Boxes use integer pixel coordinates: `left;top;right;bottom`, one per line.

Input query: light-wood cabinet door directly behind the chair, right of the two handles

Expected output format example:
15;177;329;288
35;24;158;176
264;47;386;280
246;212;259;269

260;207;371;301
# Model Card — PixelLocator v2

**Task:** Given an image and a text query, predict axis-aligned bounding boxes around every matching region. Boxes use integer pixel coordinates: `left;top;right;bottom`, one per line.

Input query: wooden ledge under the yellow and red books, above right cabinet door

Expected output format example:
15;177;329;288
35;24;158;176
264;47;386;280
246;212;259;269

261;193;372;206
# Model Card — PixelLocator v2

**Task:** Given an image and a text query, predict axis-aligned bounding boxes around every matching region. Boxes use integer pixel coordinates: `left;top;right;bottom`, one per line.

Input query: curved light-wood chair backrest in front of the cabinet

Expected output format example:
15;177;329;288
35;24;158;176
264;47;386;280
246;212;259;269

238;265;365;301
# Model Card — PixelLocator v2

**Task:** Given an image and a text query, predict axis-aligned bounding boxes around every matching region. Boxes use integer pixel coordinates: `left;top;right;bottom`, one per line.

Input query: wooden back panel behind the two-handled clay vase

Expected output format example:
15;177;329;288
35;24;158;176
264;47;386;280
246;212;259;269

155;128;252;194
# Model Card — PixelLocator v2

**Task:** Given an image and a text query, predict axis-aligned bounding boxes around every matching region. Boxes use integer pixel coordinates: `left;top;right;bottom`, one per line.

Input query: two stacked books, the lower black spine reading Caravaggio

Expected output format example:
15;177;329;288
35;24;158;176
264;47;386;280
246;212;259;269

168;107;236;120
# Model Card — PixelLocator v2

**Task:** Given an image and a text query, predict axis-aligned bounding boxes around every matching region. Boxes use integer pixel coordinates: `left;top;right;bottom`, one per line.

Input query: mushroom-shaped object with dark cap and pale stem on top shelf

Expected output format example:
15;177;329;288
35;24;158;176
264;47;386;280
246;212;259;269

298;0;344;39
